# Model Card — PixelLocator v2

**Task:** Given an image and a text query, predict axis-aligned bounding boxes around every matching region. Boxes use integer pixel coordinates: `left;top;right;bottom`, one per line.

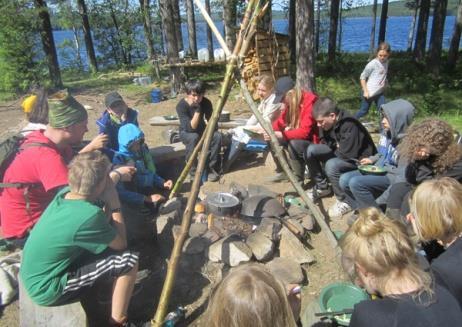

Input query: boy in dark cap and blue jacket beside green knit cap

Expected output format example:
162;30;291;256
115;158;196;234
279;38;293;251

96;92;138;159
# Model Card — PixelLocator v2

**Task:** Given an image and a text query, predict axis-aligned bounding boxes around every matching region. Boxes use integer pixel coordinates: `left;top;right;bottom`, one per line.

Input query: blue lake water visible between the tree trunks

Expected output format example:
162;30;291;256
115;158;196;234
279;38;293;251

53;16;455;66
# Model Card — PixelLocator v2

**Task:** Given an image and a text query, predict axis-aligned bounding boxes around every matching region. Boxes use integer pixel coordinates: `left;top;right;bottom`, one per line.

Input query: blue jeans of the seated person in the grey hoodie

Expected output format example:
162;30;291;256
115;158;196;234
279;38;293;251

339;170;390;209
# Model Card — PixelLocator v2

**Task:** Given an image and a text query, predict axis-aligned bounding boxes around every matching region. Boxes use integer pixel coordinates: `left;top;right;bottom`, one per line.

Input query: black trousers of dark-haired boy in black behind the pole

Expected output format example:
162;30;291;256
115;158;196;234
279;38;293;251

180;131;222;172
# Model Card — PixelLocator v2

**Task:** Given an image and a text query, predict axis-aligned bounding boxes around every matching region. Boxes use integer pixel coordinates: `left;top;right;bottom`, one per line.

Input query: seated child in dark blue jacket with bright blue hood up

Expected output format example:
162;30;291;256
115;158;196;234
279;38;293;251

112;124;172;208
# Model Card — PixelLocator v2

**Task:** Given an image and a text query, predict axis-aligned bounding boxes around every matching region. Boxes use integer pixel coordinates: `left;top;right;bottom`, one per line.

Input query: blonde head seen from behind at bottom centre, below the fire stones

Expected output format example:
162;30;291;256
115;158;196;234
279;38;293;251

204;264;299;327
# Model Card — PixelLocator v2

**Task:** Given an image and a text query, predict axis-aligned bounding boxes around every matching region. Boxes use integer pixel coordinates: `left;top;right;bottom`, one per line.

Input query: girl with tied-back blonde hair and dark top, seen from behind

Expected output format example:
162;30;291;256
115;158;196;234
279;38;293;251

340;208;462;327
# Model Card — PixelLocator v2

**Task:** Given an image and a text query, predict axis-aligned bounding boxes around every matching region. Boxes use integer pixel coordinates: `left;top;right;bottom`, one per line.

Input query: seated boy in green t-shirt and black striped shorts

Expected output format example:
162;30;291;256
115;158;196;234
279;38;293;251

20;151;138;326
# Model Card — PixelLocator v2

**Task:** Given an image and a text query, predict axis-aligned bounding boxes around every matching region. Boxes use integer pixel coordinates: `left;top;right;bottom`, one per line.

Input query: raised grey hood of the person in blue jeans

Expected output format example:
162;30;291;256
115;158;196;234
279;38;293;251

381;99;415;145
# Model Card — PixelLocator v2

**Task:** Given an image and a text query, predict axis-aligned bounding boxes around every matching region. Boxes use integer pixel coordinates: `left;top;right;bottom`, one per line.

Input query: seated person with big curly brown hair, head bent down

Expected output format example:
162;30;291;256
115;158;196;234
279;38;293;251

387;118;462;218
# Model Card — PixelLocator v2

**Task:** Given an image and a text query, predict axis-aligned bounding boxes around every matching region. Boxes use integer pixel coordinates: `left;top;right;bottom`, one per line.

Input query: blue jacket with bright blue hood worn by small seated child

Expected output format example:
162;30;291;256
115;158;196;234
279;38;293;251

112;124;165;204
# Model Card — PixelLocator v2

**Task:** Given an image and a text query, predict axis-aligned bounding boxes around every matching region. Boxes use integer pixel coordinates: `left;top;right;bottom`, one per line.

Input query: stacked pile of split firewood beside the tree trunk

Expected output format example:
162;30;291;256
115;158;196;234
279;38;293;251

241;30;290;98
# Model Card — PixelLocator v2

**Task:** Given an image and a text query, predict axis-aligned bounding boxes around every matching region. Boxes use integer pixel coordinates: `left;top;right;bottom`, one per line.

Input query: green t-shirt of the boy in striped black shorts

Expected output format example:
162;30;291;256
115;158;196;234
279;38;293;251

20;187;116;305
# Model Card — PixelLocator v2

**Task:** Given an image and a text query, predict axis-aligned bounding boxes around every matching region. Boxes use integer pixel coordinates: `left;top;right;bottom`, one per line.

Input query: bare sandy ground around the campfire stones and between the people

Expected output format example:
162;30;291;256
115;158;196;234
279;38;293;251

0;86;346;326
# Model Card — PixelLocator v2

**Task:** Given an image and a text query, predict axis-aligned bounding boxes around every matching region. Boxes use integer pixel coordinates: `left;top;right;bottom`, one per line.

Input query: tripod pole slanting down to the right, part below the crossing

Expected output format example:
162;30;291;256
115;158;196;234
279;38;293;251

240;79;339;251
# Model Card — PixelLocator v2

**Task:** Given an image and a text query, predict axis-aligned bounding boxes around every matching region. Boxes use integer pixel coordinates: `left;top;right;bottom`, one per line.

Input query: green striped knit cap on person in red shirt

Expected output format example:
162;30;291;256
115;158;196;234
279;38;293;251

48;90;88;128
